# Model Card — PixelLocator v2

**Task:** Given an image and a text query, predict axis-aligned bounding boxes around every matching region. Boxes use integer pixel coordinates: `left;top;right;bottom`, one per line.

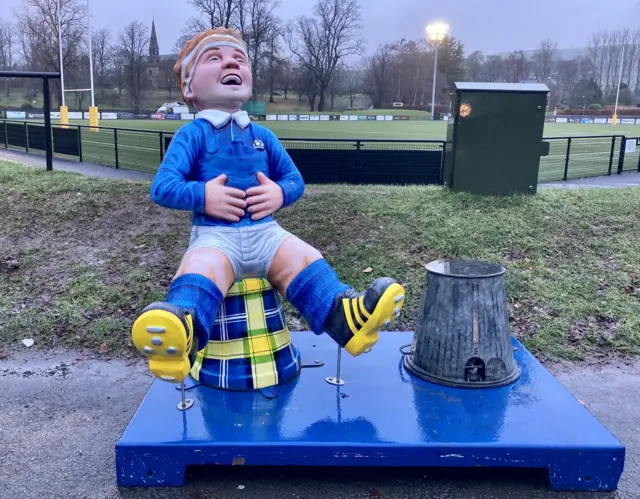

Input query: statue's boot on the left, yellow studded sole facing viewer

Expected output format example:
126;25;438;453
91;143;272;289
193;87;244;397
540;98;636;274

131;302;198;383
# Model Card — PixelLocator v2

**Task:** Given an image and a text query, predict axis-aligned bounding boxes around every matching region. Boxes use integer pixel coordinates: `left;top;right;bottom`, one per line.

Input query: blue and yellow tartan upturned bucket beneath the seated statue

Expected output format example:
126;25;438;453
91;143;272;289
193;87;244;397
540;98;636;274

191;278;300;391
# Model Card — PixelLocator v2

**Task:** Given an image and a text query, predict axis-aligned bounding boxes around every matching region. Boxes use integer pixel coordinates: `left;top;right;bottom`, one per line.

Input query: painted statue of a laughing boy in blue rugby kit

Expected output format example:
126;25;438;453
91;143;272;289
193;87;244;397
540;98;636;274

132;28;405;382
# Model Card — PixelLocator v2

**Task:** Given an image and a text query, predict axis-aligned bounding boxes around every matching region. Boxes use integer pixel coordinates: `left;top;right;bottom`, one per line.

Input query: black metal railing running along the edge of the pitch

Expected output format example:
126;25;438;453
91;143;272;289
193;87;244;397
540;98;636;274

0;119;640;184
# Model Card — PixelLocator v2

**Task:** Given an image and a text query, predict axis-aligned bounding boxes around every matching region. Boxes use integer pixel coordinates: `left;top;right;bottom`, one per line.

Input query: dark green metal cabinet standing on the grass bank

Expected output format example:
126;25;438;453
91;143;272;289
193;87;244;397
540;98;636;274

443;82;549;195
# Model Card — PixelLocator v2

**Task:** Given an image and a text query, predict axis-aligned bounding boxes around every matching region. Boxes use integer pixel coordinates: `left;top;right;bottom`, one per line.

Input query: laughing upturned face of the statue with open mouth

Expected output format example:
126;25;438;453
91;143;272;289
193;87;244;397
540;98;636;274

185;46;252;112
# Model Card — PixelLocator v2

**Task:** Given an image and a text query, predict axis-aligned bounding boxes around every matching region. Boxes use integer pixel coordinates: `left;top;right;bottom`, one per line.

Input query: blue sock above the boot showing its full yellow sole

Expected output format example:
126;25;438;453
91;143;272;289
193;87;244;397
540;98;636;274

165;274;223;350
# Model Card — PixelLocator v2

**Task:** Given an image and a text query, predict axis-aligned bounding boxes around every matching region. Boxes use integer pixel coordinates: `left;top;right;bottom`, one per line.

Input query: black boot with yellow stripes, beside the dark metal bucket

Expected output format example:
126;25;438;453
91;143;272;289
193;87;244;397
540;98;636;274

324;277;406;357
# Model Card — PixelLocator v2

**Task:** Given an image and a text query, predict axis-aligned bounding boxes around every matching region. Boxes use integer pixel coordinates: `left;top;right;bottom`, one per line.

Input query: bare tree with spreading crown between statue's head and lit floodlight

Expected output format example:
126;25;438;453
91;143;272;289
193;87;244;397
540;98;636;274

286;0;362;111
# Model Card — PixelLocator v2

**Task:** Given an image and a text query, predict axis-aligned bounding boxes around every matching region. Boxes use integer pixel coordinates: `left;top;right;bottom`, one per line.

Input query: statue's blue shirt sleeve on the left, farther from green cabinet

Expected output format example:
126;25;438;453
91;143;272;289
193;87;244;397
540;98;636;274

151;124;205;213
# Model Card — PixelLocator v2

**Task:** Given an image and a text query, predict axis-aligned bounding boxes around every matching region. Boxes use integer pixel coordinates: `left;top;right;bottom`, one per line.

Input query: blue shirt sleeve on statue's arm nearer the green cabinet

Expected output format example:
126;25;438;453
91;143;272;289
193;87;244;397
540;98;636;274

262;127;304;208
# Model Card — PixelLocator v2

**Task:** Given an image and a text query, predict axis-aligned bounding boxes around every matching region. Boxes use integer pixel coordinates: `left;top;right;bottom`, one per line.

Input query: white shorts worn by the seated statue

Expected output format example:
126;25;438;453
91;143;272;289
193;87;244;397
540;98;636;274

187;221;291;280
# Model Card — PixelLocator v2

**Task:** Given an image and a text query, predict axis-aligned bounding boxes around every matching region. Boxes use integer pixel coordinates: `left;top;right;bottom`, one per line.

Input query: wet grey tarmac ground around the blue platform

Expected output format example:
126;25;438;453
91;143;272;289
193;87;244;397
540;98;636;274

0;348;640;499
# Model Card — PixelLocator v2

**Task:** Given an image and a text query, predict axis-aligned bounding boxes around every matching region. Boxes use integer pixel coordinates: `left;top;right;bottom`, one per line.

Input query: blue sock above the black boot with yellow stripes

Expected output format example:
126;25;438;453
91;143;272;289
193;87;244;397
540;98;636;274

287;258;349;334
